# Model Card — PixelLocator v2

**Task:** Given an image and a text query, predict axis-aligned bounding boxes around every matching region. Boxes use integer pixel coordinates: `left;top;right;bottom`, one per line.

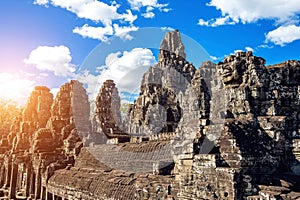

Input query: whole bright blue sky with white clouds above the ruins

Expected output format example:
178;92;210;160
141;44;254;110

0;0;300;103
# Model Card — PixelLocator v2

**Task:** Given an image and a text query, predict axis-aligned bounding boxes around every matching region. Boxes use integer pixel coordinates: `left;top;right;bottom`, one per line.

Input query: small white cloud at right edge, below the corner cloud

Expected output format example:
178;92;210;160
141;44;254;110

266;25;300;46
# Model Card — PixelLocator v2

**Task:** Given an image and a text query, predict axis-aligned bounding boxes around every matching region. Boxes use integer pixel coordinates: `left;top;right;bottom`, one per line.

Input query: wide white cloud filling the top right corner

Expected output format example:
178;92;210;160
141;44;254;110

207;0;300;25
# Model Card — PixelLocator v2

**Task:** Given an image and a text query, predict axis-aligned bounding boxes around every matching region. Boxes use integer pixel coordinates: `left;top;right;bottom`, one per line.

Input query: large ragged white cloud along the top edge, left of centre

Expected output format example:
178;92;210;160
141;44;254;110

34;0;137;42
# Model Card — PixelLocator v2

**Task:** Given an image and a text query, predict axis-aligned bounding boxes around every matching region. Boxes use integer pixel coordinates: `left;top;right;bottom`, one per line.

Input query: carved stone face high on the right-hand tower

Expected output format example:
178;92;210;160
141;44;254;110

221;62;242;85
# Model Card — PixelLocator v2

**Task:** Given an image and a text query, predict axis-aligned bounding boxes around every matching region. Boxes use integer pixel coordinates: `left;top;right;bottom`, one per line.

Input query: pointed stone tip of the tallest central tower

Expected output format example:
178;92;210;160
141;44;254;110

159;30;186;60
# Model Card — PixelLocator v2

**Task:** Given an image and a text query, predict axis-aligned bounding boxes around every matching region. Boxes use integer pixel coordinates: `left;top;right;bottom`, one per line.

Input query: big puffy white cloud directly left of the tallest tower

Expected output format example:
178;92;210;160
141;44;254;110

75;48;156;99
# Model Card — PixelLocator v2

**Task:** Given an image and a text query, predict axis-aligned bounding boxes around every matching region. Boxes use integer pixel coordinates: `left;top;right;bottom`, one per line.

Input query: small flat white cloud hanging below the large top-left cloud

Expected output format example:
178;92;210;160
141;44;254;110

73;24;113;42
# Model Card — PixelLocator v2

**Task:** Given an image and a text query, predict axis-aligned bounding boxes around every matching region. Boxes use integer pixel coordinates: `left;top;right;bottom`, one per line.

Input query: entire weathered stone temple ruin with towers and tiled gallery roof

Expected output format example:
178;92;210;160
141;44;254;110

0;31;300;200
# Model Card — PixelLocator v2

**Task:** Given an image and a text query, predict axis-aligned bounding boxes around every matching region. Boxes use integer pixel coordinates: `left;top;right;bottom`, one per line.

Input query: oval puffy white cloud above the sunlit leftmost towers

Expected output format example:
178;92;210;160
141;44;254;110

24;45;76;77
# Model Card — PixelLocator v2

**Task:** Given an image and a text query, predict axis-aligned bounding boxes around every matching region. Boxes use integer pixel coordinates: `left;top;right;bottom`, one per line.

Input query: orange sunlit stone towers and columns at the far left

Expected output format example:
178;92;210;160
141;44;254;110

0;81;90;199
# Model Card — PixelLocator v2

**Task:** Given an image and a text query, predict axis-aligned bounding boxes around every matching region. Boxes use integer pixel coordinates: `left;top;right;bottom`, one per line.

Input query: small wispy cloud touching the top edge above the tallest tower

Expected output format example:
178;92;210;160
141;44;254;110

128;0;170;18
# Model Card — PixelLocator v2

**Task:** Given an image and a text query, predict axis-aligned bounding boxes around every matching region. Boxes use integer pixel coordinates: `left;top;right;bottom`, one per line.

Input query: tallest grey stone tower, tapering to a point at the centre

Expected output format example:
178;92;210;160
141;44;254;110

126;31;196;136
